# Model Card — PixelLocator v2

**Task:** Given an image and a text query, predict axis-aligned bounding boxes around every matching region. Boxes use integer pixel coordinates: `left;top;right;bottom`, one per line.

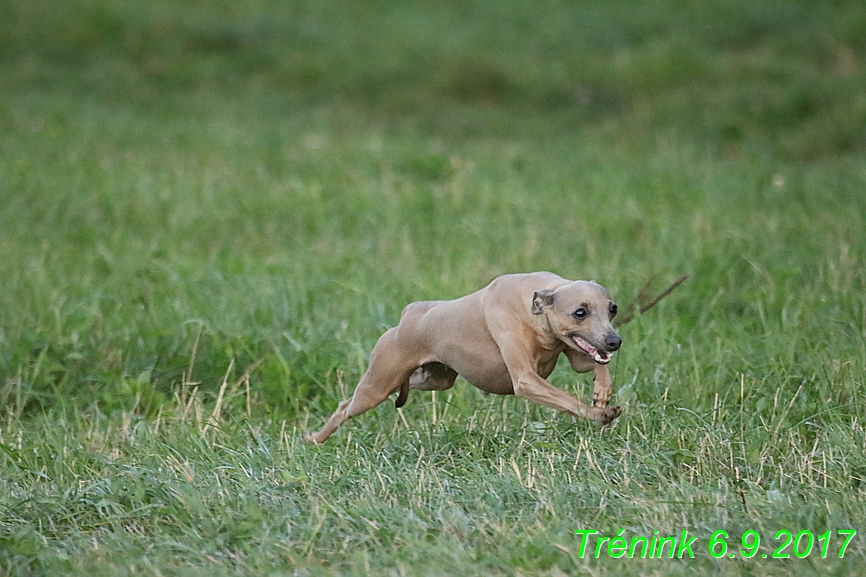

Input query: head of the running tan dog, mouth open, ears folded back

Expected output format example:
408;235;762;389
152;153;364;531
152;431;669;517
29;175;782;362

531;280;622;365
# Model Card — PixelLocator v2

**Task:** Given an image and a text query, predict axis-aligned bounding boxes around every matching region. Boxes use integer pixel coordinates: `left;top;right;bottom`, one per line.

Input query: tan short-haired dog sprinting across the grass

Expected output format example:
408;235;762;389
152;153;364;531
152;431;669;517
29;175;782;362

304;272;622;443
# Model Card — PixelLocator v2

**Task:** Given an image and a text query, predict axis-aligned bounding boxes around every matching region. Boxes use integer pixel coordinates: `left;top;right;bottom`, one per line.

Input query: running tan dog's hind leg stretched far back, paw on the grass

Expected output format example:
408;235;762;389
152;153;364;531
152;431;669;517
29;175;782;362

304;327;418;444
